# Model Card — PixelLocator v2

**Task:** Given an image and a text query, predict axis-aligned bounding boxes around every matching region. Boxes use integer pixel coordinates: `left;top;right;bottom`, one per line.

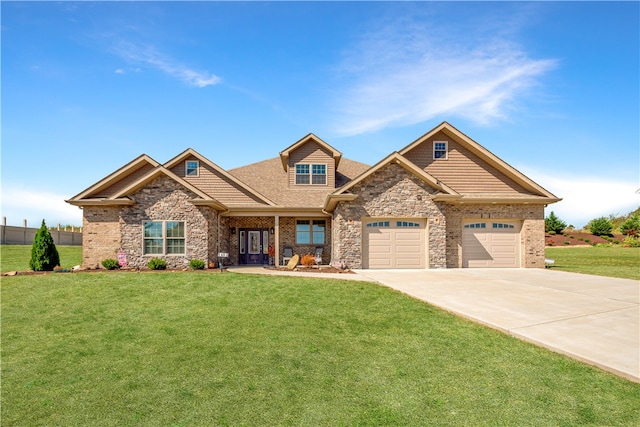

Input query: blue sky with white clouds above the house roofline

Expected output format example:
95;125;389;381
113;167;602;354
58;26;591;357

0;1;640;227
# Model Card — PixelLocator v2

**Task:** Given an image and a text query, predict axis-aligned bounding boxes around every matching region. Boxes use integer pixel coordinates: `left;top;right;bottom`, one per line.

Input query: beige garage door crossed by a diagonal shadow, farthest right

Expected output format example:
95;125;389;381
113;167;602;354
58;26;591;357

462;221;520;268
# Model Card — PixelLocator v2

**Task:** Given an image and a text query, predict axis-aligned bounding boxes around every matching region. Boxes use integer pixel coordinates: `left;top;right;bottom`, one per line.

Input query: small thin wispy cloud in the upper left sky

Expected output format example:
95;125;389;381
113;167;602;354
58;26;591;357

115;42;222;88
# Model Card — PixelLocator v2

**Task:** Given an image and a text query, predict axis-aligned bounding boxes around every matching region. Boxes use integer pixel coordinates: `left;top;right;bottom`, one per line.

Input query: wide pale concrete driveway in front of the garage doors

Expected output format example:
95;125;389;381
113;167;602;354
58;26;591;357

356;269;640;382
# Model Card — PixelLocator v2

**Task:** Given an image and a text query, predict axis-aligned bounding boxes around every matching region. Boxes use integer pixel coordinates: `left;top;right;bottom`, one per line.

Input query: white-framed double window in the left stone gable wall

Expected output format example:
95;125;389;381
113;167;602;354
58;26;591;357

143;221;185;255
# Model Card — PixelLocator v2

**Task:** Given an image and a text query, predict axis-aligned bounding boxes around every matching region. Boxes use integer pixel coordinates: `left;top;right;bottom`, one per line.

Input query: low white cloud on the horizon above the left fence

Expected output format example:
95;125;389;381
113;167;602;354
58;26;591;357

1;186;82;227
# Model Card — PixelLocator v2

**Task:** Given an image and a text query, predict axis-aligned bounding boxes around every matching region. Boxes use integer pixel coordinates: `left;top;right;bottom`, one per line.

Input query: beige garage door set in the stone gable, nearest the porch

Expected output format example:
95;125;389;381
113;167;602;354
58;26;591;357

363;218;426;268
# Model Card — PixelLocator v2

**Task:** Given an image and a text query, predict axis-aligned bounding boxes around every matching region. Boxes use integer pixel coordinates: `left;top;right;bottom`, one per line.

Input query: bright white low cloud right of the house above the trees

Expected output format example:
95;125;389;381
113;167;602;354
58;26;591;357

519;167;640;228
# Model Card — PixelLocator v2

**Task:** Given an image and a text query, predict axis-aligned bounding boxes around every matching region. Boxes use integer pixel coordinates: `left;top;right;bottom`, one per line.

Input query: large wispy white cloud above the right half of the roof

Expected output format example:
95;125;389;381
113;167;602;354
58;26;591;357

335;13;556;135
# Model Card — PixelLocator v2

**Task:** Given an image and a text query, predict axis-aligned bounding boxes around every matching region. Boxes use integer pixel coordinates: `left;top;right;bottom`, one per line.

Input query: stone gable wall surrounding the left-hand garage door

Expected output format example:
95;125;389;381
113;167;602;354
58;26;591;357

333;163;447;268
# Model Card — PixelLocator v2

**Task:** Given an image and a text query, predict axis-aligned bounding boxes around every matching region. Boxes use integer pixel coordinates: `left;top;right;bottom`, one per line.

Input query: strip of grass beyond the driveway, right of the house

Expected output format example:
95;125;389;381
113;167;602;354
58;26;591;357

545;246;640;280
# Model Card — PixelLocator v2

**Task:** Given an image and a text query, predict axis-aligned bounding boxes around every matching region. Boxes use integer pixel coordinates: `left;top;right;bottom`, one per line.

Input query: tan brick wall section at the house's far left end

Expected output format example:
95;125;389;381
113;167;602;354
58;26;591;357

82;206;120;268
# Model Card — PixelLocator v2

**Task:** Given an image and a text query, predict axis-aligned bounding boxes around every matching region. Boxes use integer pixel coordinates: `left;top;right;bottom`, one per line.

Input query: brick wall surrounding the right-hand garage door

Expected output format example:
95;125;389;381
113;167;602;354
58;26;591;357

447;204;544;268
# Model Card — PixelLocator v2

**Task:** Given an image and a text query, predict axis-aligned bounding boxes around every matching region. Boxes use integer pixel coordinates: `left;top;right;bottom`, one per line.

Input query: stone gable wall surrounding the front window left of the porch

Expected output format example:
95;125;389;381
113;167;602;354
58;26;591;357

120;177;218;268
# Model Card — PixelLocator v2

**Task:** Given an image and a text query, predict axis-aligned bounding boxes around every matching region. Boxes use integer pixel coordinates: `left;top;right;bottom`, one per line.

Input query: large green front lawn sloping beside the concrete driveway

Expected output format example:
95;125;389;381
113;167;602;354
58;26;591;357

1;272;640;426
